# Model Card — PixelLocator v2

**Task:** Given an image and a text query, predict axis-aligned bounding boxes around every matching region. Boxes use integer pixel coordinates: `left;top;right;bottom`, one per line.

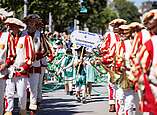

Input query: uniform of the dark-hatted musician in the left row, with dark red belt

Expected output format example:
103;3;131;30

29;31;53;110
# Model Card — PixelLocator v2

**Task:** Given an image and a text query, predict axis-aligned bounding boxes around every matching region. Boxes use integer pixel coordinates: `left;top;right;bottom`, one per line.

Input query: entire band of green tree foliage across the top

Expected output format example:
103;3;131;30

1;0;139;32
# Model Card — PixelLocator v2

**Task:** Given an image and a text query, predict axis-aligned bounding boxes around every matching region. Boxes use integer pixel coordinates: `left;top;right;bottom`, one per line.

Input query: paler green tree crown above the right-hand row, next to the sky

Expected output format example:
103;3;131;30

114;0;140;23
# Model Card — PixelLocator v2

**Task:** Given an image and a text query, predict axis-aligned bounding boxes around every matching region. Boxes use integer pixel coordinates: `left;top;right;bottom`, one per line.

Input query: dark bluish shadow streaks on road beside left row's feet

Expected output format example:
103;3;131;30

37;98;93;115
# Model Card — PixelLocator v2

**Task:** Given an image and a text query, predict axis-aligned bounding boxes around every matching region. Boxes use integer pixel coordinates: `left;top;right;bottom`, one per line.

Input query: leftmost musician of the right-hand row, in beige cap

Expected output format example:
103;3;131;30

100;19;126;112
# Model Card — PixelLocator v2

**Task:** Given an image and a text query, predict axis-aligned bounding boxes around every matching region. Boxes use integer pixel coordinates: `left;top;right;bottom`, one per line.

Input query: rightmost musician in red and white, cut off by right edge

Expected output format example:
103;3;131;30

132;10;157;115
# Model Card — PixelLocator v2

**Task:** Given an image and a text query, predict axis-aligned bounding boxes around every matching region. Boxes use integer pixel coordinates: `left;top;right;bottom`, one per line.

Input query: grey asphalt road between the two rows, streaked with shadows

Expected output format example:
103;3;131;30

38;84;115;115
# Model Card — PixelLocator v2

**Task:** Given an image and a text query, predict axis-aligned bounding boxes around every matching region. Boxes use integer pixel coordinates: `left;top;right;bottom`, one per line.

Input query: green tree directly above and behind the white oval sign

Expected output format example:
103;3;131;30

79;0;117;33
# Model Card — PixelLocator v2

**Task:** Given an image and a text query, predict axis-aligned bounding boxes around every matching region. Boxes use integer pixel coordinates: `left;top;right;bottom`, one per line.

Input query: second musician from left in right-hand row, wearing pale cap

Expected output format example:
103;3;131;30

115;25;134;115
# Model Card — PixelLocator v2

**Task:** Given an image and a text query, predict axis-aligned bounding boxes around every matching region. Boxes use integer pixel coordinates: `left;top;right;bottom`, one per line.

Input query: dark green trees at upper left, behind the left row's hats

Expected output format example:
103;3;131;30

1;0;80;31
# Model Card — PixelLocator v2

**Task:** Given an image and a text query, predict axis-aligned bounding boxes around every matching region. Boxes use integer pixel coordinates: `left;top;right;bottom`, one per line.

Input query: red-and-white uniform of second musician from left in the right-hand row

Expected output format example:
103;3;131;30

116;40;134;115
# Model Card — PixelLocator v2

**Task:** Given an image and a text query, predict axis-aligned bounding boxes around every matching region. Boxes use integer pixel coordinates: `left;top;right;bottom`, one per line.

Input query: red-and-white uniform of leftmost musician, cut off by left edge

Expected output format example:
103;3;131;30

0;32;15;115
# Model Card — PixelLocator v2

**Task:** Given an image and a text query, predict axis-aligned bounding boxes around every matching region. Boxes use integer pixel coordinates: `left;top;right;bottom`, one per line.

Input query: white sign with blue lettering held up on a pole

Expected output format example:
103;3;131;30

70;30;100;49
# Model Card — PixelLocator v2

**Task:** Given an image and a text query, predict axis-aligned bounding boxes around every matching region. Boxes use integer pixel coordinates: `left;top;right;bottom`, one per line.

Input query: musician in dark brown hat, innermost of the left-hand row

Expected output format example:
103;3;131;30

23;14;53;115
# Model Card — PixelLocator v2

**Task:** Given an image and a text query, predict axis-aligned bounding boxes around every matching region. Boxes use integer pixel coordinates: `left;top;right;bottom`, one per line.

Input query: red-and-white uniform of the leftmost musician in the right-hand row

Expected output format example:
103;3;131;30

100;32;120;104
